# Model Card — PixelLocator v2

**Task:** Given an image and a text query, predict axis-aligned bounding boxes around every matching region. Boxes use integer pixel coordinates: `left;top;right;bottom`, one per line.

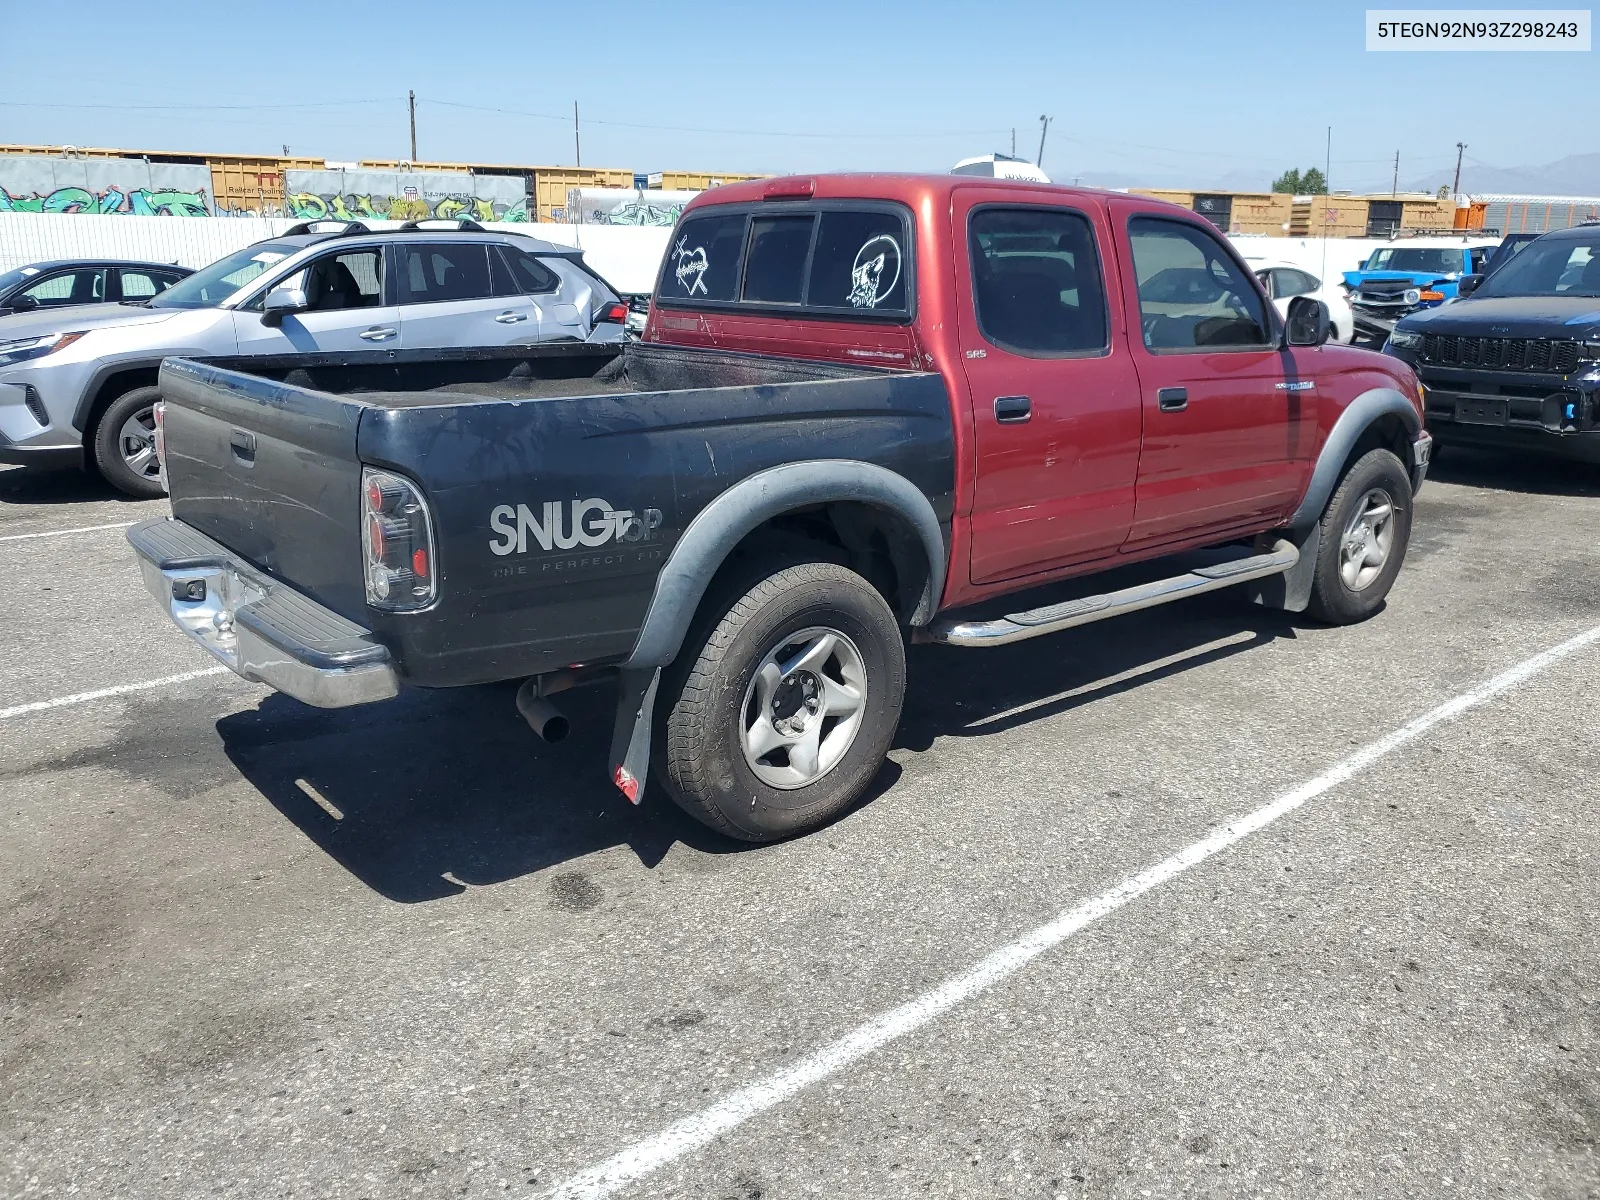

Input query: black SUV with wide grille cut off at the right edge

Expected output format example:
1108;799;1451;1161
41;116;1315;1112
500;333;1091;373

1384;224;1600;462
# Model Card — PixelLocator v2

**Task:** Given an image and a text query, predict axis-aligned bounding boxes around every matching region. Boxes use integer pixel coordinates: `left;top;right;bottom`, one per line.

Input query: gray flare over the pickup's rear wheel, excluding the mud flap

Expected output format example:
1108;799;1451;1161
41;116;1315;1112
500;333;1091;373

622;459;946;670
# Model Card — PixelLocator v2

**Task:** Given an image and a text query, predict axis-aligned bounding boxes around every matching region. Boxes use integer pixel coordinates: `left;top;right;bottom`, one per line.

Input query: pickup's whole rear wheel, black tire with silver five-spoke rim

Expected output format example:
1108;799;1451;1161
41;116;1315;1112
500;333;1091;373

656;562;906;842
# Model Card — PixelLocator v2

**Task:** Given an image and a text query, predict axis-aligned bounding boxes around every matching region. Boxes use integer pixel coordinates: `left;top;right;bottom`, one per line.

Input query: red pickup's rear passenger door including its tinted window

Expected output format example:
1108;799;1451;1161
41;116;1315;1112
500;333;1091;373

952;195;1141;584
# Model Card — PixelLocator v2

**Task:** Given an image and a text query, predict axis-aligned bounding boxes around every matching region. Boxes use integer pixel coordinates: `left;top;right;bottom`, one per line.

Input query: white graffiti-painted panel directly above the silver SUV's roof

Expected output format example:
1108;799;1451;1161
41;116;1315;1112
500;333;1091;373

283;171;528;221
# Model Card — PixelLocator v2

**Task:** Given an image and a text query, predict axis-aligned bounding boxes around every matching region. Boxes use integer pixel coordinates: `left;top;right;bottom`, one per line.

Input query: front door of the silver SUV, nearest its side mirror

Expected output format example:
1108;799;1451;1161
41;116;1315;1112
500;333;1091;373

234;248;400;354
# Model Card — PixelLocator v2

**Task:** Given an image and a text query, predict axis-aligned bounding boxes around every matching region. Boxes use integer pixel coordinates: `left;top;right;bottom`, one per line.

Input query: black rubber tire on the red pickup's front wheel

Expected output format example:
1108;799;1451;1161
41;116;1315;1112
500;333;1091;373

1307;450;1411;626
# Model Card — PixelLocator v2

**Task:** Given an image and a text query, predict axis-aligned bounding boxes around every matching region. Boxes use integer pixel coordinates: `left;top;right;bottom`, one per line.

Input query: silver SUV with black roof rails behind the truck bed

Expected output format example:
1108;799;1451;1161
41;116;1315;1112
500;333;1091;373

0;221;627;496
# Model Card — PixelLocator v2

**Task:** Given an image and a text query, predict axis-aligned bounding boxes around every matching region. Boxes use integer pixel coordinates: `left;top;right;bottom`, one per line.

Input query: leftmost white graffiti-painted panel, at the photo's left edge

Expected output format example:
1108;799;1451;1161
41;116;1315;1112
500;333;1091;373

0;154;211;216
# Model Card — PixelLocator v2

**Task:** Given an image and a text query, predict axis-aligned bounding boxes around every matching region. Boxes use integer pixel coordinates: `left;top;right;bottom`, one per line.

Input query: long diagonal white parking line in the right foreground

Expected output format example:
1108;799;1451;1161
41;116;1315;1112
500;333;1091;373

547;626;1600;1200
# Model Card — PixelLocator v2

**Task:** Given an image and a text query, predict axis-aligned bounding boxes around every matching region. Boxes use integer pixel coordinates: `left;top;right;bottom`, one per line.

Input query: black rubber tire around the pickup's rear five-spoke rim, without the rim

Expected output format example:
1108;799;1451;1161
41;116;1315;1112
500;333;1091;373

654;560;906;842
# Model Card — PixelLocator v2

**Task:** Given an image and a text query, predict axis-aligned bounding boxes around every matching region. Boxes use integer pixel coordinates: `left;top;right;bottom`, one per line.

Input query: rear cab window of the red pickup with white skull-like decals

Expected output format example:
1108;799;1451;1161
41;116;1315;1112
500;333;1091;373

656;200;915;323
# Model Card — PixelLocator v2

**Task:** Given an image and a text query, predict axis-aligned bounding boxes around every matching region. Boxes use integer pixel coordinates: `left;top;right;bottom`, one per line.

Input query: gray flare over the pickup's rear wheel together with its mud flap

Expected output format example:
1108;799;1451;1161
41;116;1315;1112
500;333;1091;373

611;459;946;805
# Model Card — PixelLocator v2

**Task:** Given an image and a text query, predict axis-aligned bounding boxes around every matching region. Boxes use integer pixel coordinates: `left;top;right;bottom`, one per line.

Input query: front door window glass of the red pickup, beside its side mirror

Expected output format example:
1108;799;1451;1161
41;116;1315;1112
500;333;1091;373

1128;216;1272;352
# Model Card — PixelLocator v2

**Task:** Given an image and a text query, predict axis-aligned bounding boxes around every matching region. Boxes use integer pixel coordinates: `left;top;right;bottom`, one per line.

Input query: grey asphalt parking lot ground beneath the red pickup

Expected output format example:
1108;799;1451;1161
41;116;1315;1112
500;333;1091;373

0;453;1600;1200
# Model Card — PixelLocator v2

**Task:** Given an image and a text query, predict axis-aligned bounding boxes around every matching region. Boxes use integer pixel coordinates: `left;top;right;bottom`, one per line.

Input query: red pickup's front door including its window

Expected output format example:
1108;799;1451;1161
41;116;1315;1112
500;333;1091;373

1112;202;1317;550
